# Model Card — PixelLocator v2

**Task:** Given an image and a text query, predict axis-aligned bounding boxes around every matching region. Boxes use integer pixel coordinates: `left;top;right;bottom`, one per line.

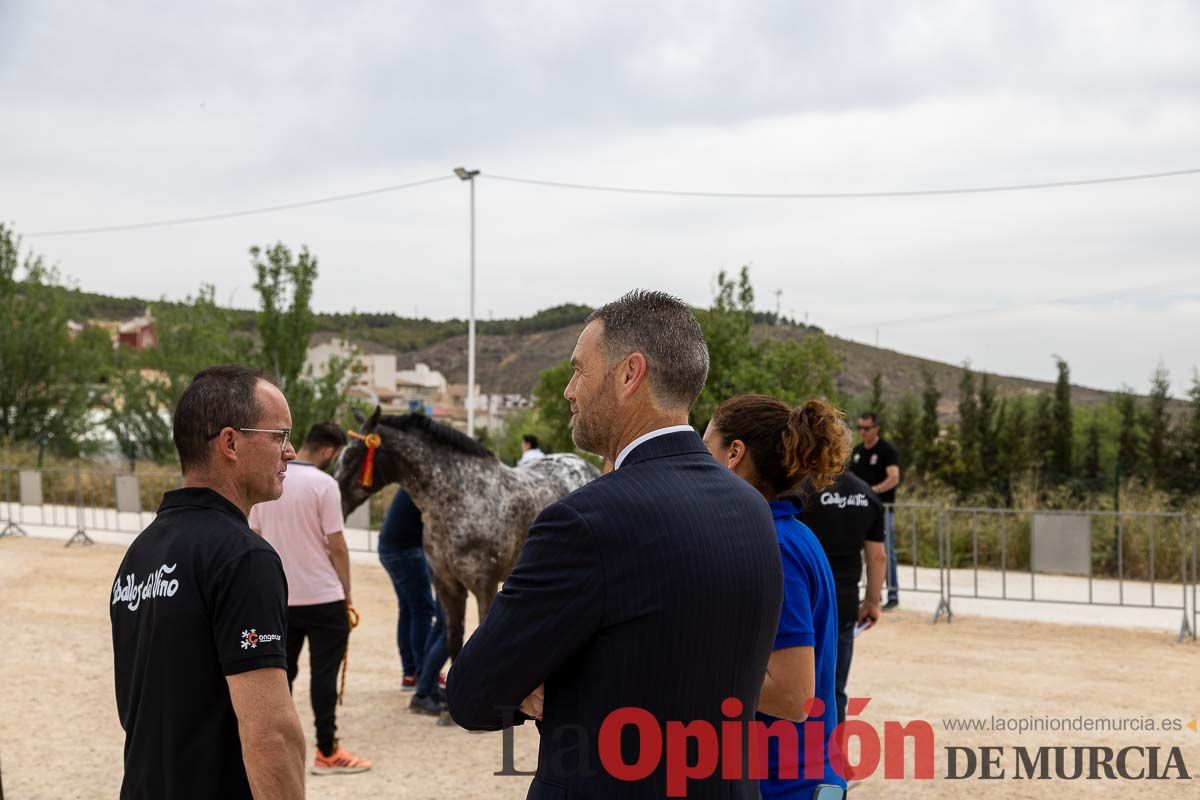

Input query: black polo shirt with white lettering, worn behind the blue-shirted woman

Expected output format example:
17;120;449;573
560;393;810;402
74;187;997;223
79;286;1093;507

800;471;883;625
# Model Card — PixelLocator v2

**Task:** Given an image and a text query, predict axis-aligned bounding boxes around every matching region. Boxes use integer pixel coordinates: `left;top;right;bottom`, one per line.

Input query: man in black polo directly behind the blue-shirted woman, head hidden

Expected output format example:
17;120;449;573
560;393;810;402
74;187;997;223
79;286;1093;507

800;473;887;723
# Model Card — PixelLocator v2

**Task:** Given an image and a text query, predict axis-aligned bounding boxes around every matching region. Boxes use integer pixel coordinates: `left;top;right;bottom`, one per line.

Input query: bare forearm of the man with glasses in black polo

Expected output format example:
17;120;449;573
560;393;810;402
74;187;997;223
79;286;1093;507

226;667;304;800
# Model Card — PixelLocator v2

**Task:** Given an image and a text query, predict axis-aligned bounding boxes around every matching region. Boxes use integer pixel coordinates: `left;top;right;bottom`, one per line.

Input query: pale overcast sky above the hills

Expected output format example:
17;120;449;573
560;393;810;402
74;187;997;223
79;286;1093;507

0;0;1200;393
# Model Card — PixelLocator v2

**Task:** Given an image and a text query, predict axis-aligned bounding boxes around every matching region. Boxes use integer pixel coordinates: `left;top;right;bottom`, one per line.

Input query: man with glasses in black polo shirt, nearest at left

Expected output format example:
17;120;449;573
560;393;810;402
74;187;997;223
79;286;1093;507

109;366;304;800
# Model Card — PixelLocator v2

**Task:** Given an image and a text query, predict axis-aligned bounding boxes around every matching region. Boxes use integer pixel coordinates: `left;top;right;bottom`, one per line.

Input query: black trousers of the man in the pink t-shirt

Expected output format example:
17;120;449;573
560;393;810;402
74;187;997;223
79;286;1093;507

287;600;350;756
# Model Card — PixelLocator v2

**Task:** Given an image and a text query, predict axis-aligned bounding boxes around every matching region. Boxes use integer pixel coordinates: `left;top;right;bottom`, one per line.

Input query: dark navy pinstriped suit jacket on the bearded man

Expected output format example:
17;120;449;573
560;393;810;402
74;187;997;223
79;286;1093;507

446;432;782;800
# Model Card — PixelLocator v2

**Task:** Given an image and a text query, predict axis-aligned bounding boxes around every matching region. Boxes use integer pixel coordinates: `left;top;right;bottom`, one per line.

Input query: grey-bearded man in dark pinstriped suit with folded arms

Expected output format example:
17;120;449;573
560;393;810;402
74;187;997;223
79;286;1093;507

446;291;782;800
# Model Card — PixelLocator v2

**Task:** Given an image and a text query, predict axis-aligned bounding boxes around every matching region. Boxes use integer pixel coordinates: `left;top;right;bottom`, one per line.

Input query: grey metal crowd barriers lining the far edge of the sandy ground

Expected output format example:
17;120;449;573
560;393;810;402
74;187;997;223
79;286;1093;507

0;465;1200;640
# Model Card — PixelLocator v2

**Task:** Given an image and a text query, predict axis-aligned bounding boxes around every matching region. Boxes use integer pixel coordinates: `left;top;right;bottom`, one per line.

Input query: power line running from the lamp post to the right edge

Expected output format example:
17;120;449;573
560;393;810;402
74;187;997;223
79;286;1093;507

484;168;1200;200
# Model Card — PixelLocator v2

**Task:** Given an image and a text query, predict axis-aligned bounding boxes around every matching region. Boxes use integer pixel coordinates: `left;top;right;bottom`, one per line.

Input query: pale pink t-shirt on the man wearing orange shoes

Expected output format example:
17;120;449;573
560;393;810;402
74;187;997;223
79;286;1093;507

250;462;346;606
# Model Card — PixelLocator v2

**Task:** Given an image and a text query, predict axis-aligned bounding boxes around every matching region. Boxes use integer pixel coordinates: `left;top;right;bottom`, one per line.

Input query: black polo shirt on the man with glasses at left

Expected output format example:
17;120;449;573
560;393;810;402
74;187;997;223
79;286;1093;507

109;488;288;800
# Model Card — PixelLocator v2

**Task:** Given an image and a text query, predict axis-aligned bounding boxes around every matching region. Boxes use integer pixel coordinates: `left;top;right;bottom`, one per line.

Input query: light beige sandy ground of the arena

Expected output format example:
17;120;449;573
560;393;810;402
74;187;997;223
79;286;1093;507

0;539;1200;800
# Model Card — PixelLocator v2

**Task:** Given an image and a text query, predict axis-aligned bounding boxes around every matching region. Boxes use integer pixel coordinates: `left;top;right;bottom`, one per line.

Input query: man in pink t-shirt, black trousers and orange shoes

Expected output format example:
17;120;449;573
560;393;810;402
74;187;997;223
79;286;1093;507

250;422;371;775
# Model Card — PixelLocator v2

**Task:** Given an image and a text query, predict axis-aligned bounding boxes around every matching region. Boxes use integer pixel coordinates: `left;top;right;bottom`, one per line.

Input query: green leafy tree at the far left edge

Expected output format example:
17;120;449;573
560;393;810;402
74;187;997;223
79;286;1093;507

0;223;104;455
